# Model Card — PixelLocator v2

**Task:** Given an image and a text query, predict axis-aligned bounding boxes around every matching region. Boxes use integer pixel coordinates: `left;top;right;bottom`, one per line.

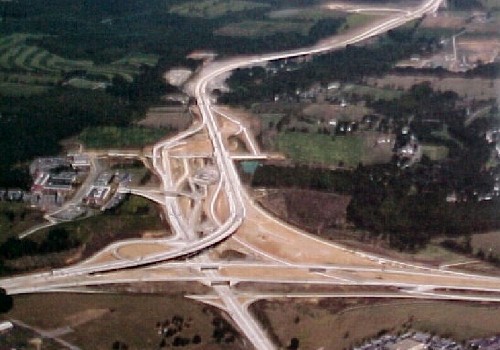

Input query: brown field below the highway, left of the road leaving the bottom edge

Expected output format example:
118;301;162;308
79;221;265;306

4;294;243;350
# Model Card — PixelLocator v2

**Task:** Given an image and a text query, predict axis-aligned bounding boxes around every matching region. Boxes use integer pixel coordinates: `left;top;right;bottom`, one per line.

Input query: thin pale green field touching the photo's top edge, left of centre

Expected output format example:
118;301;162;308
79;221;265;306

170;0;269;18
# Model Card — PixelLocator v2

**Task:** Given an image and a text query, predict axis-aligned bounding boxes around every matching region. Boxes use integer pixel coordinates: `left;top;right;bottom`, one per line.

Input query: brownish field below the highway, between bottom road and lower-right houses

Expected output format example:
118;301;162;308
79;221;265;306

252;299;500;349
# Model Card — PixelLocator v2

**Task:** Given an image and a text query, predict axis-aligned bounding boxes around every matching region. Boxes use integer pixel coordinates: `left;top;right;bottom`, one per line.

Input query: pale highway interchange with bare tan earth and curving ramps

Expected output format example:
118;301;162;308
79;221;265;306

0;0;500;350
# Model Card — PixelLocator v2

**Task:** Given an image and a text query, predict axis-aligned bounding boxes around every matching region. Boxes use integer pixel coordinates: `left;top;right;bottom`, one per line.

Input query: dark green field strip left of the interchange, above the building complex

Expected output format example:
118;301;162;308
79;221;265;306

79;126;169;149
